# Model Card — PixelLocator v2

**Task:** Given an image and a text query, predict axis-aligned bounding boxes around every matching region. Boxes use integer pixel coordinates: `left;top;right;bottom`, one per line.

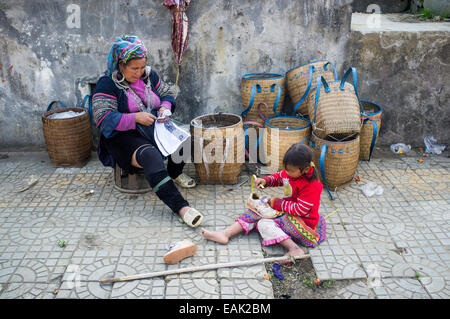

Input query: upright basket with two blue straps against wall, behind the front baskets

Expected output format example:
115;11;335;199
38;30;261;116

241;73;286;117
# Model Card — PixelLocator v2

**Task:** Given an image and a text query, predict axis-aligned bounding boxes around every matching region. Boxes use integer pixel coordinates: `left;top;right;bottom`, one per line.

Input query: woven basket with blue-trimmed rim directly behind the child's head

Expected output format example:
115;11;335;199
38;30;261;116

263;116;311;172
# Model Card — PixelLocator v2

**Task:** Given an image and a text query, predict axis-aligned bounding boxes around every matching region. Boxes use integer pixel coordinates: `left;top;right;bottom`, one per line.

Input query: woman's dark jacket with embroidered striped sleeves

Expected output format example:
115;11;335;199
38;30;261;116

92;69;176;167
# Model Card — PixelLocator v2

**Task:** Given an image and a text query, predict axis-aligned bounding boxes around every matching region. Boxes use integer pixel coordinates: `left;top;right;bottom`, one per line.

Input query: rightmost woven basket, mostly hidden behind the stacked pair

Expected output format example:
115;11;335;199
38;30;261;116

359;100;383;161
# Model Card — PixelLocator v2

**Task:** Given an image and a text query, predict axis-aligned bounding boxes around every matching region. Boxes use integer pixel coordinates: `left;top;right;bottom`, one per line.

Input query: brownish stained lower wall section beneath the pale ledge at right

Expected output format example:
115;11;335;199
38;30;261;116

344;32;450;146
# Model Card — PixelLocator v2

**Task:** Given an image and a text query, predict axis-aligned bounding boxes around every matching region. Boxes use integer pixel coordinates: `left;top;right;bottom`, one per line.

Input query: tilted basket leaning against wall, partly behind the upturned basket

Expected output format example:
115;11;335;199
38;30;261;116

286;60;338;116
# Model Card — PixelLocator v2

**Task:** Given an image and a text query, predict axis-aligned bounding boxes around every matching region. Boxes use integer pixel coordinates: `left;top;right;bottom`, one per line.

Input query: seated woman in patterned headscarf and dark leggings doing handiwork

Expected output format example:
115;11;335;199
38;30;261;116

92;36;203;227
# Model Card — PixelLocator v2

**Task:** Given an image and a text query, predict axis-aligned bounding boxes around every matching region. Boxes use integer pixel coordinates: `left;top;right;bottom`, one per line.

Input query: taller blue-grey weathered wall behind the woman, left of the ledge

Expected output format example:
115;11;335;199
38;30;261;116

0;0;351;148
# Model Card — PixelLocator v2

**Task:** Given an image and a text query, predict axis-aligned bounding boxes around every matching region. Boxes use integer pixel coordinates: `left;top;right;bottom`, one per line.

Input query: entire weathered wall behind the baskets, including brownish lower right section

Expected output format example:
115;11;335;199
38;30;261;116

0;0;450;149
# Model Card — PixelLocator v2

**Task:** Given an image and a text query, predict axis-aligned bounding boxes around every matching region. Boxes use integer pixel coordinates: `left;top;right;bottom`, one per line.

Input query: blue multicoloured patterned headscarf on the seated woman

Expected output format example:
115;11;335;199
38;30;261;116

105;35;148;75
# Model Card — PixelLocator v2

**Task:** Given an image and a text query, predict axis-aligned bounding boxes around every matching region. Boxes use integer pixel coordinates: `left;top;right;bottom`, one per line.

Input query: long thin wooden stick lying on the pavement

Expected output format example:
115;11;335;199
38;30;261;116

100;254;309;284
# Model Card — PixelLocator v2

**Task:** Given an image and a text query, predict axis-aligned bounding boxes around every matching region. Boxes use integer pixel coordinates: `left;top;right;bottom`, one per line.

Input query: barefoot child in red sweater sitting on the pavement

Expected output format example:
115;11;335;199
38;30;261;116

202;143;326;262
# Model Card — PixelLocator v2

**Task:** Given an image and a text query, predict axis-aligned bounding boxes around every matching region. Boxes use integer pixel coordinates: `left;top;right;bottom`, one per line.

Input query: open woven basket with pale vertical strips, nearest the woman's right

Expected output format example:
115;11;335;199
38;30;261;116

190;113;245;184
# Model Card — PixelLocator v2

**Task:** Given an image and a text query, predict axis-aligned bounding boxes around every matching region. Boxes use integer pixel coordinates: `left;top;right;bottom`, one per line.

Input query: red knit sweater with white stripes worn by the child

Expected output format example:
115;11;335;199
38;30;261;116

263;170;323;229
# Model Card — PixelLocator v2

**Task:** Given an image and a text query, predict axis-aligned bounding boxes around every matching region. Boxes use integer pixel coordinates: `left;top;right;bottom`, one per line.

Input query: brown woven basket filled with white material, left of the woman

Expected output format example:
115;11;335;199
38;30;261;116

42;101;93;167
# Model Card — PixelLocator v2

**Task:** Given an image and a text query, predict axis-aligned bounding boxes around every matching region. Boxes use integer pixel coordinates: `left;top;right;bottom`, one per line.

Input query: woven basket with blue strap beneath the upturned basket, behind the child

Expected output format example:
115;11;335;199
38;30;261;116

310;132;360;197
